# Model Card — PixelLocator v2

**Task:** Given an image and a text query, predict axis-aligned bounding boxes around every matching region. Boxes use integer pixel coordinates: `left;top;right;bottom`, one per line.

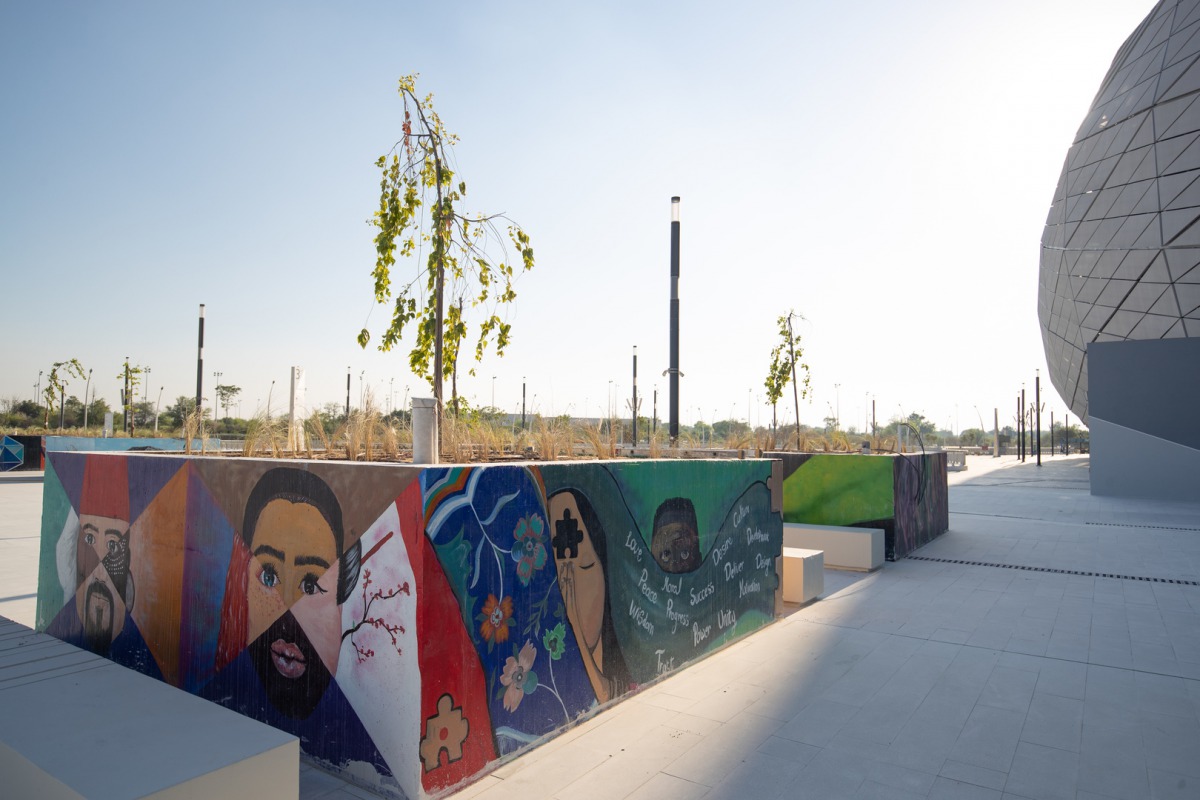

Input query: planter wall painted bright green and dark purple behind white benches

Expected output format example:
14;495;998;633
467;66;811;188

767;452;949;561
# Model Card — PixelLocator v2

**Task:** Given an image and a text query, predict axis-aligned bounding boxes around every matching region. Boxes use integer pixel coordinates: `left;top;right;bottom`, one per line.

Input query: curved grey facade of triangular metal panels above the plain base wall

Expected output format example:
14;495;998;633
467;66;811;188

1038;0;1200;420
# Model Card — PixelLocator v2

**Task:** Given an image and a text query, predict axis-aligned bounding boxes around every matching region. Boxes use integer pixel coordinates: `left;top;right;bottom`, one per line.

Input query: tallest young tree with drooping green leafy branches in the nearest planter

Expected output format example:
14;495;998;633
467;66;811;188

358;74;533;429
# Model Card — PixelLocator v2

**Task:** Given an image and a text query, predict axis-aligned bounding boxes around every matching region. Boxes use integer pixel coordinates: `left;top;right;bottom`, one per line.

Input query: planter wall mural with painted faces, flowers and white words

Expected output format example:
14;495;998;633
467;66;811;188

37;452;782;798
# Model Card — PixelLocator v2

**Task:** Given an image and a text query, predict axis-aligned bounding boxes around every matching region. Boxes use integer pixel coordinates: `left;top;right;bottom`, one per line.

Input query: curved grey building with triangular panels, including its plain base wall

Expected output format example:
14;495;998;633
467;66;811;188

1038;0;1200;500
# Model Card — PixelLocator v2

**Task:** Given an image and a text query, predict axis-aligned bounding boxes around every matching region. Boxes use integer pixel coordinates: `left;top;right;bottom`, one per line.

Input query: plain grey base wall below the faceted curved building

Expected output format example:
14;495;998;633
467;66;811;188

1087;338;1200;500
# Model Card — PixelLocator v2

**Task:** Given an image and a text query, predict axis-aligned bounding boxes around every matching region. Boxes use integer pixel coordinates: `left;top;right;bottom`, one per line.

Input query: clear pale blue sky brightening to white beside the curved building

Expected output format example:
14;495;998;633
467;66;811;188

0;0;1153;429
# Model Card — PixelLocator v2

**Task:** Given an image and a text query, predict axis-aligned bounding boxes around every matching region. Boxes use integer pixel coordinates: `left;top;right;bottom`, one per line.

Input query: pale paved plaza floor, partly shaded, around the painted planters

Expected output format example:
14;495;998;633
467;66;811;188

0;456;1200;800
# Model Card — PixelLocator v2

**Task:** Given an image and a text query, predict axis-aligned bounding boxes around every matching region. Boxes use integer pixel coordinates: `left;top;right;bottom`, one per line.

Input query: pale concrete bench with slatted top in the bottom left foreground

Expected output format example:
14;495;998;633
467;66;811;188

0;616;300;800
